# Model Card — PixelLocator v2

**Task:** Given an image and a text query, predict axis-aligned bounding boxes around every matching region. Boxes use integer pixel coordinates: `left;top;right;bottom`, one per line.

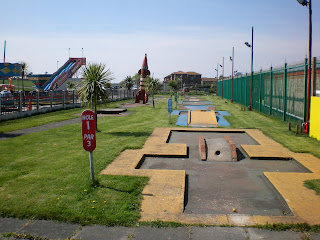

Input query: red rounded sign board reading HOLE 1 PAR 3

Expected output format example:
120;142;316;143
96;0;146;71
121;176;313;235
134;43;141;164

81;110;96;152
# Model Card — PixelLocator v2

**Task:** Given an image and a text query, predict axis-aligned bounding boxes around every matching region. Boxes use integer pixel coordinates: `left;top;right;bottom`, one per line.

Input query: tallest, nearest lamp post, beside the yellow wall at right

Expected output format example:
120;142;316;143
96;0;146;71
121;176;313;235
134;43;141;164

297;0;312;133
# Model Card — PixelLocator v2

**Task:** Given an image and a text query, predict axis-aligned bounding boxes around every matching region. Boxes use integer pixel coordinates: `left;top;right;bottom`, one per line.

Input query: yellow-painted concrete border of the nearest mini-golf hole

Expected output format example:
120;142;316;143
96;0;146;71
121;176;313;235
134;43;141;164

100;128;320;226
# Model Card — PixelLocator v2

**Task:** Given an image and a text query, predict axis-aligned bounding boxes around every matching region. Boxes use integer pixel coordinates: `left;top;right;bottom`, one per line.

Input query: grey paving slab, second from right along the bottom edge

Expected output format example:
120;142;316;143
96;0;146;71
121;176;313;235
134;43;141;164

247;228;301;240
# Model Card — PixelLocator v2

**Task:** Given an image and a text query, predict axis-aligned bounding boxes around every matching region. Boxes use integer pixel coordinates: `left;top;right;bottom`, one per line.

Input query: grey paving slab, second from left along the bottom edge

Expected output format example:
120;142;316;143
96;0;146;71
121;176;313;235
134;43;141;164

19;220;80;239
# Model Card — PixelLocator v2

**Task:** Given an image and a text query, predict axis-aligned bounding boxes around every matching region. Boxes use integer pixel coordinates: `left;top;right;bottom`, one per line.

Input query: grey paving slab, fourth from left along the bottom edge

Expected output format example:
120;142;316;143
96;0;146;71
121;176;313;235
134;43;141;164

132;227;189;240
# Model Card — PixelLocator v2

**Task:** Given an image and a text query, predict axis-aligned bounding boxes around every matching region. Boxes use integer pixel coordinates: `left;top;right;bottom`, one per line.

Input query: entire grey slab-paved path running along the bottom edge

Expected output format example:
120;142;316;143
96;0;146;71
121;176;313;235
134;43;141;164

0;218;320;240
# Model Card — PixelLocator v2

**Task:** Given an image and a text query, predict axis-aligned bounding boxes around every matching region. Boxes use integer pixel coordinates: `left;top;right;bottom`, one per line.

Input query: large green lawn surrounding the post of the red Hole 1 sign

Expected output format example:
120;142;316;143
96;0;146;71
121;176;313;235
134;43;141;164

0;99;178;226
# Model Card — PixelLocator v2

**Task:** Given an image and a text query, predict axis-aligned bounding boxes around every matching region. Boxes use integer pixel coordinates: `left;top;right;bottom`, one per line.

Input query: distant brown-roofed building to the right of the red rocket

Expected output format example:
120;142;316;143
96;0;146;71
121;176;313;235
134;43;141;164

163;71;201;90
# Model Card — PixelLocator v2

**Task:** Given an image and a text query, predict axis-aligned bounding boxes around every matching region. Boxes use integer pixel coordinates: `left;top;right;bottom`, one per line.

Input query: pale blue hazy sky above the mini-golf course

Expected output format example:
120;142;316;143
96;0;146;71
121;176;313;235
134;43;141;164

0;0;320;82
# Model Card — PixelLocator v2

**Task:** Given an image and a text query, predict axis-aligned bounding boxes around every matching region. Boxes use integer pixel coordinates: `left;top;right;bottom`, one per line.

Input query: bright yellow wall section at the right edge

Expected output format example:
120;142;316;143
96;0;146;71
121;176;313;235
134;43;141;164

309;97;320;141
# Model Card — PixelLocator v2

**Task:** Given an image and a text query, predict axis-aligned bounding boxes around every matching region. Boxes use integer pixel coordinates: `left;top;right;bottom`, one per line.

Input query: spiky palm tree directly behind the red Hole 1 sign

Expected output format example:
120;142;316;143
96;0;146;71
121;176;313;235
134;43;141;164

78;63;114;131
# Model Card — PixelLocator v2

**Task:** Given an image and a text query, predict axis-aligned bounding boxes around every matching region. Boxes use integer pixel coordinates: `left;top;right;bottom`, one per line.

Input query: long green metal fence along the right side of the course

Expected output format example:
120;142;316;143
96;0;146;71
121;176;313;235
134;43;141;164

218;59;320;122
